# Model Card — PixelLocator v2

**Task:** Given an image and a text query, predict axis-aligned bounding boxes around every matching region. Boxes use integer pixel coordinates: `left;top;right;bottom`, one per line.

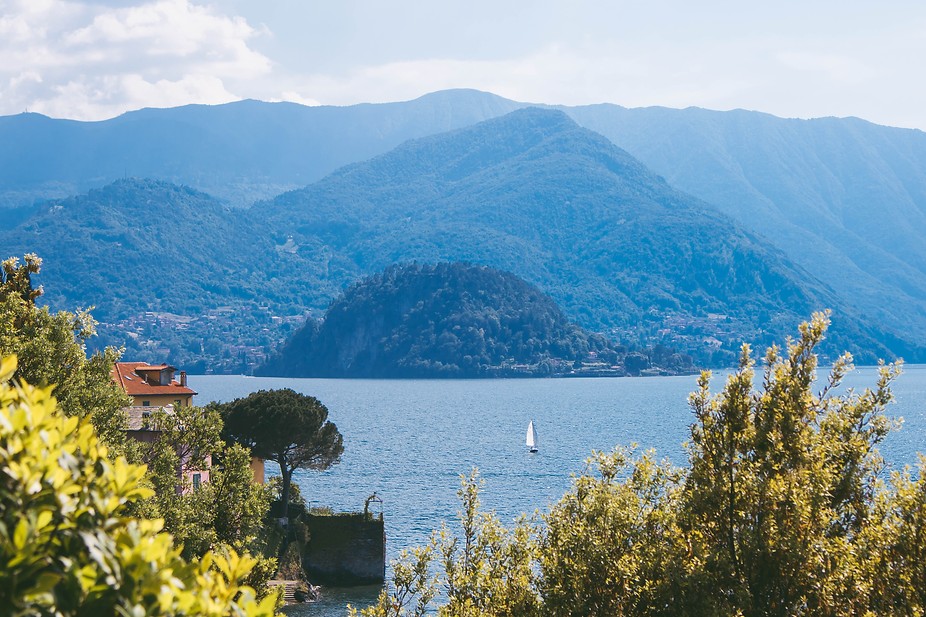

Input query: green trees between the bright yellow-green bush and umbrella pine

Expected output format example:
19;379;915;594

0;255;275;593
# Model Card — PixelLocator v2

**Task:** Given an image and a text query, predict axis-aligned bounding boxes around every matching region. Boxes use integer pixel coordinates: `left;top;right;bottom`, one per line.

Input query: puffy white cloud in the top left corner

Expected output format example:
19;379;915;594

0;0;272;120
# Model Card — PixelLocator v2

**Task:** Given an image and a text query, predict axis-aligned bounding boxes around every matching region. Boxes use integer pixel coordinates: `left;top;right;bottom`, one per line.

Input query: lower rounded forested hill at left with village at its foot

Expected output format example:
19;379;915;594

0;179;330;372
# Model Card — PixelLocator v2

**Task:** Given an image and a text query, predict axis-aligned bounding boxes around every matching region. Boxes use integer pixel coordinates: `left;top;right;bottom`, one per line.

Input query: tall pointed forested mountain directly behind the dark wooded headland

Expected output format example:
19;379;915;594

253;108;888;361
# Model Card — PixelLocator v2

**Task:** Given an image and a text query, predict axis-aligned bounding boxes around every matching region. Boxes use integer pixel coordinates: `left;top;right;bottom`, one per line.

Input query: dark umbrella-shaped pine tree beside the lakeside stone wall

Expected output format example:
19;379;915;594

218;388;344;518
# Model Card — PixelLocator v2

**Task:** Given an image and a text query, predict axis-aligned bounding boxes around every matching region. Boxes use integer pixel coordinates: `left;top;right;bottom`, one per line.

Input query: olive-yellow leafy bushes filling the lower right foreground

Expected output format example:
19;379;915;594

350;314;926;617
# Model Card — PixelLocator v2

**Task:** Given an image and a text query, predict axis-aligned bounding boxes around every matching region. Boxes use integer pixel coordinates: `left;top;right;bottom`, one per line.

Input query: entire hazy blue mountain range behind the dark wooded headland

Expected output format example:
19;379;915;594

0;91;926;370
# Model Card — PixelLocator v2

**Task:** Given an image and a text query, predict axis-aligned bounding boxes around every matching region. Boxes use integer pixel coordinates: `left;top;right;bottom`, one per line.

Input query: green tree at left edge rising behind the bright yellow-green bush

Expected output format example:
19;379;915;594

0;254;133;452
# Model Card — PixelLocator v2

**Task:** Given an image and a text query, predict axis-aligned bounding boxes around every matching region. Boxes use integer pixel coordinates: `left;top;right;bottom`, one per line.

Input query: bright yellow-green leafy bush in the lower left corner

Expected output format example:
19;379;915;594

0;357;276;617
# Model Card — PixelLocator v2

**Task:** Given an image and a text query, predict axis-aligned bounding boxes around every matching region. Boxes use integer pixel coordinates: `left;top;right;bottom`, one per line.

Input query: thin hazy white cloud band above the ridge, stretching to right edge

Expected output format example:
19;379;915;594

277;22;926;128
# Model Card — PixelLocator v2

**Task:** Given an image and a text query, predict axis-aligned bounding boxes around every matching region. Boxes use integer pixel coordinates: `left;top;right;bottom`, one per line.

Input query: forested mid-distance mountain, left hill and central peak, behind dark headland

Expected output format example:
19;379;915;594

0;109;916;372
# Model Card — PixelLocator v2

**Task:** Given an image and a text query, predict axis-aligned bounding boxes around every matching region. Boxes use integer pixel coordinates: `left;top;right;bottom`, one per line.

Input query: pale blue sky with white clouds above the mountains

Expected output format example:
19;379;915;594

0;0;926;130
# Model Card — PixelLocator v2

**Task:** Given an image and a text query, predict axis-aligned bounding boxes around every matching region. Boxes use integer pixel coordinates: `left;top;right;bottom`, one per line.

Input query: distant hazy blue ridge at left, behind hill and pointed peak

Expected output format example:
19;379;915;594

0;90;521;207
